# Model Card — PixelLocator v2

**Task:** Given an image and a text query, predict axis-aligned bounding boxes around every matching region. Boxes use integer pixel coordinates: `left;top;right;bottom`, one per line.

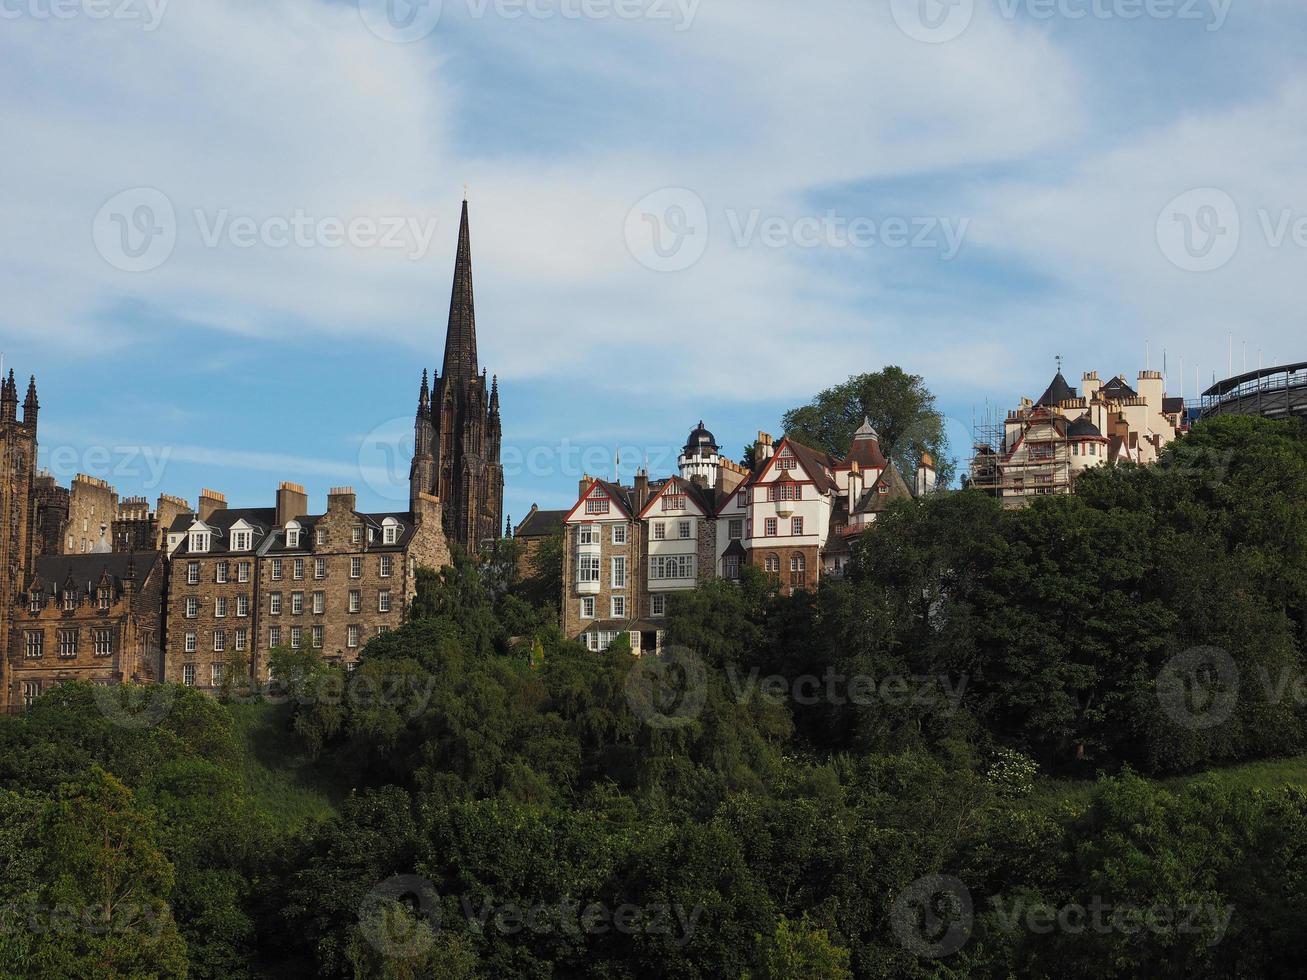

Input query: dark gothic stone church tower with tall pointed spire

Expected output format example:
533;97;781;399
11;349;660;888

409;200;503;554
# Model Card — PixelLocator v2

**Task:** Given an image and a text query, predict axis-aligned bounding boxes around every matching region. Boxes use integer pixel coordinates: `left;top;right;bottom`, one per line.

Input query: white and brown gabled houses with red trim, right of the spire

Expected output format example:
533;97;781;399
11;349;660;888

562;422;935;652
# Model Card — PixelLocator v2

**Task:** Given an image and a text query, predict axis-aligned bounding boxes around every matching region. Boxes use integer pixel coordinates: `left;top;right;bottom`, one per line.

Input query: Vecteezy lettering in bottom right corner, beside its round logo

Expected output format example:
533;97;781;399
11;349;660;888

989;895;1234;946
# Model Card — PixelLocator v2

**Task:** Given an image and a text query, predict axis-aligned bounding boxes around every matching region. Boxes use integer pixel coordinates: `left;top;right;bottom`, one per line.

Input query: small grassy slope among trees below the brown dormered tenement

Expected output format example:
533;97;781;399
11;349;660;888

227;703;348;831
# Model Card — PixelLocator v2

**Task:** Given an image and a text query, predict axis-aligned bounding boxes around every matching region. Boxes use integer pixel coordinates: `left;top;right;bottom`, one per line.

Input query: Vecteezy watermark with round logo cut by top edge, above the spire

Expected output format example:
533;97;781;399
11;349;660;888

358;0;701;44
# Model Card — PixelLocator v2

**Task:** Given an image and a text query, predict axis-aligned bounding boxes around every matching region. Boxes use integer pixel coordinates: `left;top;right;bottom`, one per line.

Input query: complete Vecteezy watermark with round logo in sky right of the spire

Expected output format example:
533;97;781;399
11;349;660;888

625;187;971;272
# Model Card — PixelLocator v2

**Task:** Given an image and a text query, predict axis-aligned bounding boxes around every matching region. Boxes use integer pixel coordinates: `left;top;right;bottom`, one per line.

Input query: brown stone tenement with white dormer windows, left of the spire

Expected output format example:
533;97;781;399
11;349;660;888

163;483;450;689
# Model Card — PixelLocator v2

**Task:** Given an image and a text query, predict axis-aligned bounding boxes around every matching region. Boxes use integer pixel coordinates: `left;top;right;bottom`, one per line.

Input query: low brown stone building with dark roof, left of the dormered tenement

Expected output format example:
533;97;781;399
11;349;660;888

8;551;165;707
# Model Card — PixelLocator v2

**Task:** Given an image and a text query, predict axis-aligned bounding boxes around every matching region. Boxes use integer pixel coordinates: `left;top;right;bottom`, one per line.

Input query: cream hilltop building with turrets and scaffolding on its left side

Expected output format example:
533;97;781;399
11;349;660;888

970;370;1184;508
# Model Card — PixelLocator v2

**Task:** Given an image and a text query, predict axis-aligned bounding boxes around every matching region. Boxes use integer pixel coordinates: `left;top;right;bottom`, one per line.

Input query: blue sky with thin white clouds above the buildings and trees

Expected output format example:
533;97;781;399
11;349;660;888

0;0;1307;520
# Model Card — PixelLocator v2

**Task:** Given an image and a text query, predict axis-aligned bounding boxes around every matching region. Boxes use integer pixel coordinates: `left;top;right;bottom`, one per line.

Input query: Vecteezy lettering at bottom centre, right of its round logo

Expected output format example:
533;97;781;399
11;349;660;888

460;895;703;949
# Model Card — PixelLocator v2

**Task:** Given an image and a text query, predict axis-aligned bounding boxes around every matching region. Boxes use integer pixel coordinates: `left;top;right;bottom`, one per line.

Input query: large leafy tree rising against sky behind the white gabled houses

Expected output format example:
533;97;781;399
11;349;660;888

782;365;955;486
